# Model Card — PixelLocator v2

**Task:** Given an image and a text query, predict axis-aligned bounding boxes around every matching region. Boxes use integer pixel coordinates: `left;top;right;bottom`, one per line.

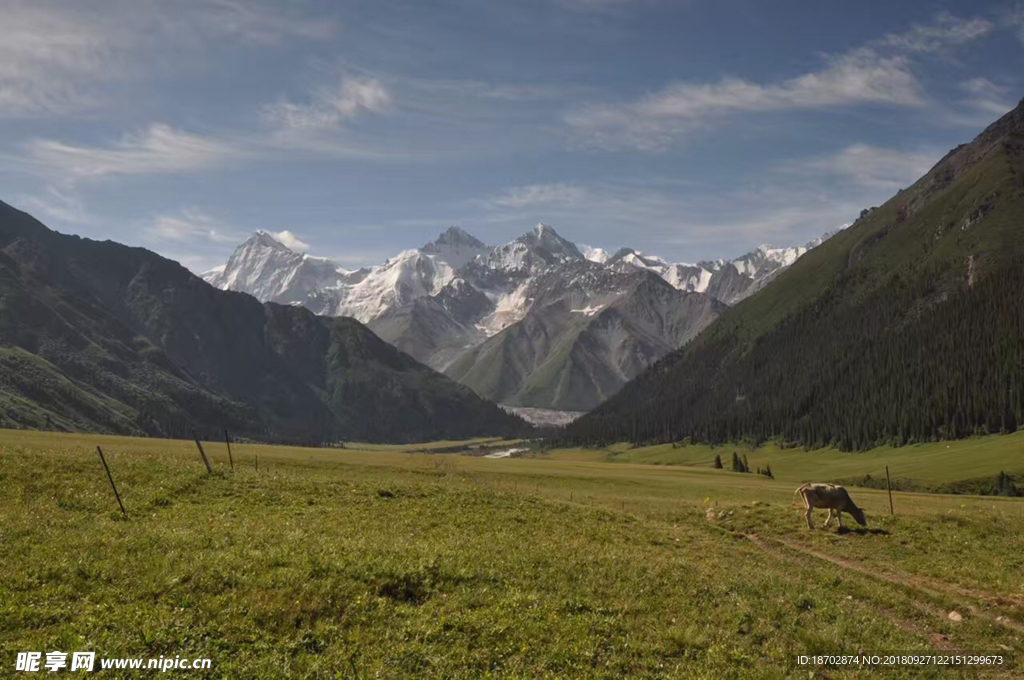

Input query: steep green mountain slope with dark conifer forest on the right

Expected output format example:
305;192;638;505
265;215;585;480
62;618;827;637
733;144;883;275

567;98;1024;450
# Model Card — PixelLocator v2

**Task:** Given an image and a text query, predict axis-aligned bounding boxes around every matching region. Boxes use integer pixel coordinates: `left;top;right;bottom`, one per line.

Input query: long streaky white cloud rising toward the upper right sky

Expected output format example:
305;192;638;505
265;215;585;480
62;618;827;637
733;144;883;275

566;48;925;151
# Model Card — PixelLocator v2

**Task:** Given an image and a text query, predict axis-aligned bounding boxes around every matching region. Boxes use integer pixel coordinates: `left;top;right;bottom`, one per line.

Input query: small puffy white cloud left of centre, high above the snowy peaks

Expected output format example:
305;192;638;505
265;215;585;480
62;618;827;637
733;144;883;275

262;78;392;130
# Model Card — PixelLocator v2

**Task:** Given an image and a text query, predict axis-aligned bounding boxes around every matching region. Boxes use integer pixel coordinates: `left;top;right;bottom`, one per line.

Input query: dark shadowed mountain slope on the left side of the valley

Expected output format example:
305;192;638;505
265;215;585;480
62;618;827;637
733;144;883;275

0;203;520;442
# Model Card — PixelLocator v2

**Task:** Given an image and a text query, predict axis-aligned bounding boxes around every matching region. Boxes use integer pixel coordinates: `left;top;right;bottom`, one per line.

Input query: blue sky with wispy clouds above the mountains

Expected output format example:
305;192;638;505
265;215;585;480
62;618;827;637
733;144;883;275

0;0;1024;272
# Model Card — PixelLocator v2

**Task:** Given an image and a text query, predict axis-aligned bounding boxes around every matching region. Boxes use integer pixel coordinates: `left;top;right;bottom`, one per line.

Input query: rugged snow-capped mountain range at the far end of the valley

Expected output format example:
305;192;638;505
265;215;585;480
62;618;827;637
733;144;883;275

204;223;826;411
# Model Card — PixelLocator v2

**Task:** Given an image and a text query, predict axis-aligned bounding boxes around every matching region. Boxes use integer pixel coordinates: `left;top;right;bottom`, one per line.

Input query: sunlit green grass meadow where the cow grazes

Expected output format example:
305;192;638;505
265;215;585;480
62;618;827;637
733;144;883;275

6;431;1024;678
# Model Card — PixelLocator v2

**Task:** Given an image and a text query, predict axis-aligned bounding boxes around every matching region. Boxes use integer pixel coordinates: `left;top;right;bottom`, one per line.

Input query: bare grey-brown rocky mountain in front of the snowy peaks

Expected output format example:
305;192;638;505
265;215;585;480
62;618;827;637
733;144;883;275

447;270;725;411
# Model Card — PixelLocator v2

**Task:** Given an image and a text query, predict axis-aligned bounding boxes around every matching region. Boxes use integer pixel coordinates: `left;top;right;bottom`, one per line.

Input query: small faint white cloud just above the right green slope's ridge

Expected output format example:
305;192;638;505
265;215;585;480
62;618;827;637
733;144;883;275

788;144;942;193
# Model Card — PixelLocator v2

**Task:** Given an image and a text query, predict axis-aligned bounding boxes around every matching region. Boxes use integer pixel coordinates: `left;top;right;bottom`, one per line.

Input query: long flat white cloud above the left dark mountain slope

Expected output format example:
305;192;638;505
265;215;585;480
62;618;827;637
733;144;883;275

23;123;245;181
